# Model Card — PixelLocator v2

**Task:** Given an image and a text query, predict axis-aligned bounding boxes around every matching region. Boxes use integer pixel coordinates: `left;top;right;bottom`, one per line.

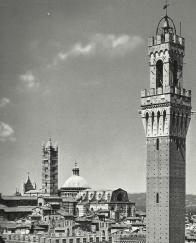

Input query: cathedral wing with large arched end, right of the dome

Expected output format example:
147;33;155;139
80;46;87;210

76;188;135;220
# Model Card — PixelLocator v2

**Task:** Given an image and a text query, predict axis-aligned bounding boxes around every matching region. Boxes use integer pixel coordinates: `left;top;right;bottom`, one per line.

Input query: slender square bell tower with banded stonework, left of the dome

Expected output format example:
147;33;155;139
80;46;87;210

42;139;58;195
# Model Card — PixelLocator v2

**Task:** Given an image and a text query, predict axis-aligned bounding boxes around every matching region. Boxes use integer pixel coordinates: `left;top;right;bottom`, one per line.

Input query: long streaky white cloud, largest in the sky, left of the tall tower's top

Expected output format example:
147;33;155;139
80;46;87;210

52;34;143;66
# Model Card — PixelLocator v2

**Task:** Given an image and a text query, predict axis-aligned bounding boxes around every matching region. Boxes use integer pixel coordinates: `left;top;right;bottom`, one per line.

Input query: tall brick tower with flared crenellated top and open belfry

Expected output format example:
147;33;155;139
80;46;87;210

141;13;191;243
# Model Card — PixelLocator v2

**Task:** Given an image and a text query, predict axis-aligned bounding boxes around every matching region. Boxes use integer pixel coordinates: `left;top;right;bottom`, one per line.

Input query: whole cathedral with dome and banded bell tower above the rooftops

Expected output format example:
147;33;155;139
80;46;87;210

0;139;135;220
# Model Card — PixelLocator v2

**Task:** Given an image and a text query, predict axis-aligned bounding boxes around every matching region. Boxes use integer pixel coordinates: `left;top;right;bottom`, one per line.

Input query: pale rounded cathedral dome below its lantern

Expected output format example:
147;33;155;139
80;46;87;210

63;175;89;188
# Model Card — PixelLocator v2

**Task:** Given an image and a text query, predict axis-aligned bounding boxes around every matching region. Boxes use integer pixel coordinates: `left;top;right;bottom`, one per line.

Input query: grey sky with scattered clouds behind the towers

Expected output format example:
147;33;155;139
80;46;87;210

0;0;196;194
